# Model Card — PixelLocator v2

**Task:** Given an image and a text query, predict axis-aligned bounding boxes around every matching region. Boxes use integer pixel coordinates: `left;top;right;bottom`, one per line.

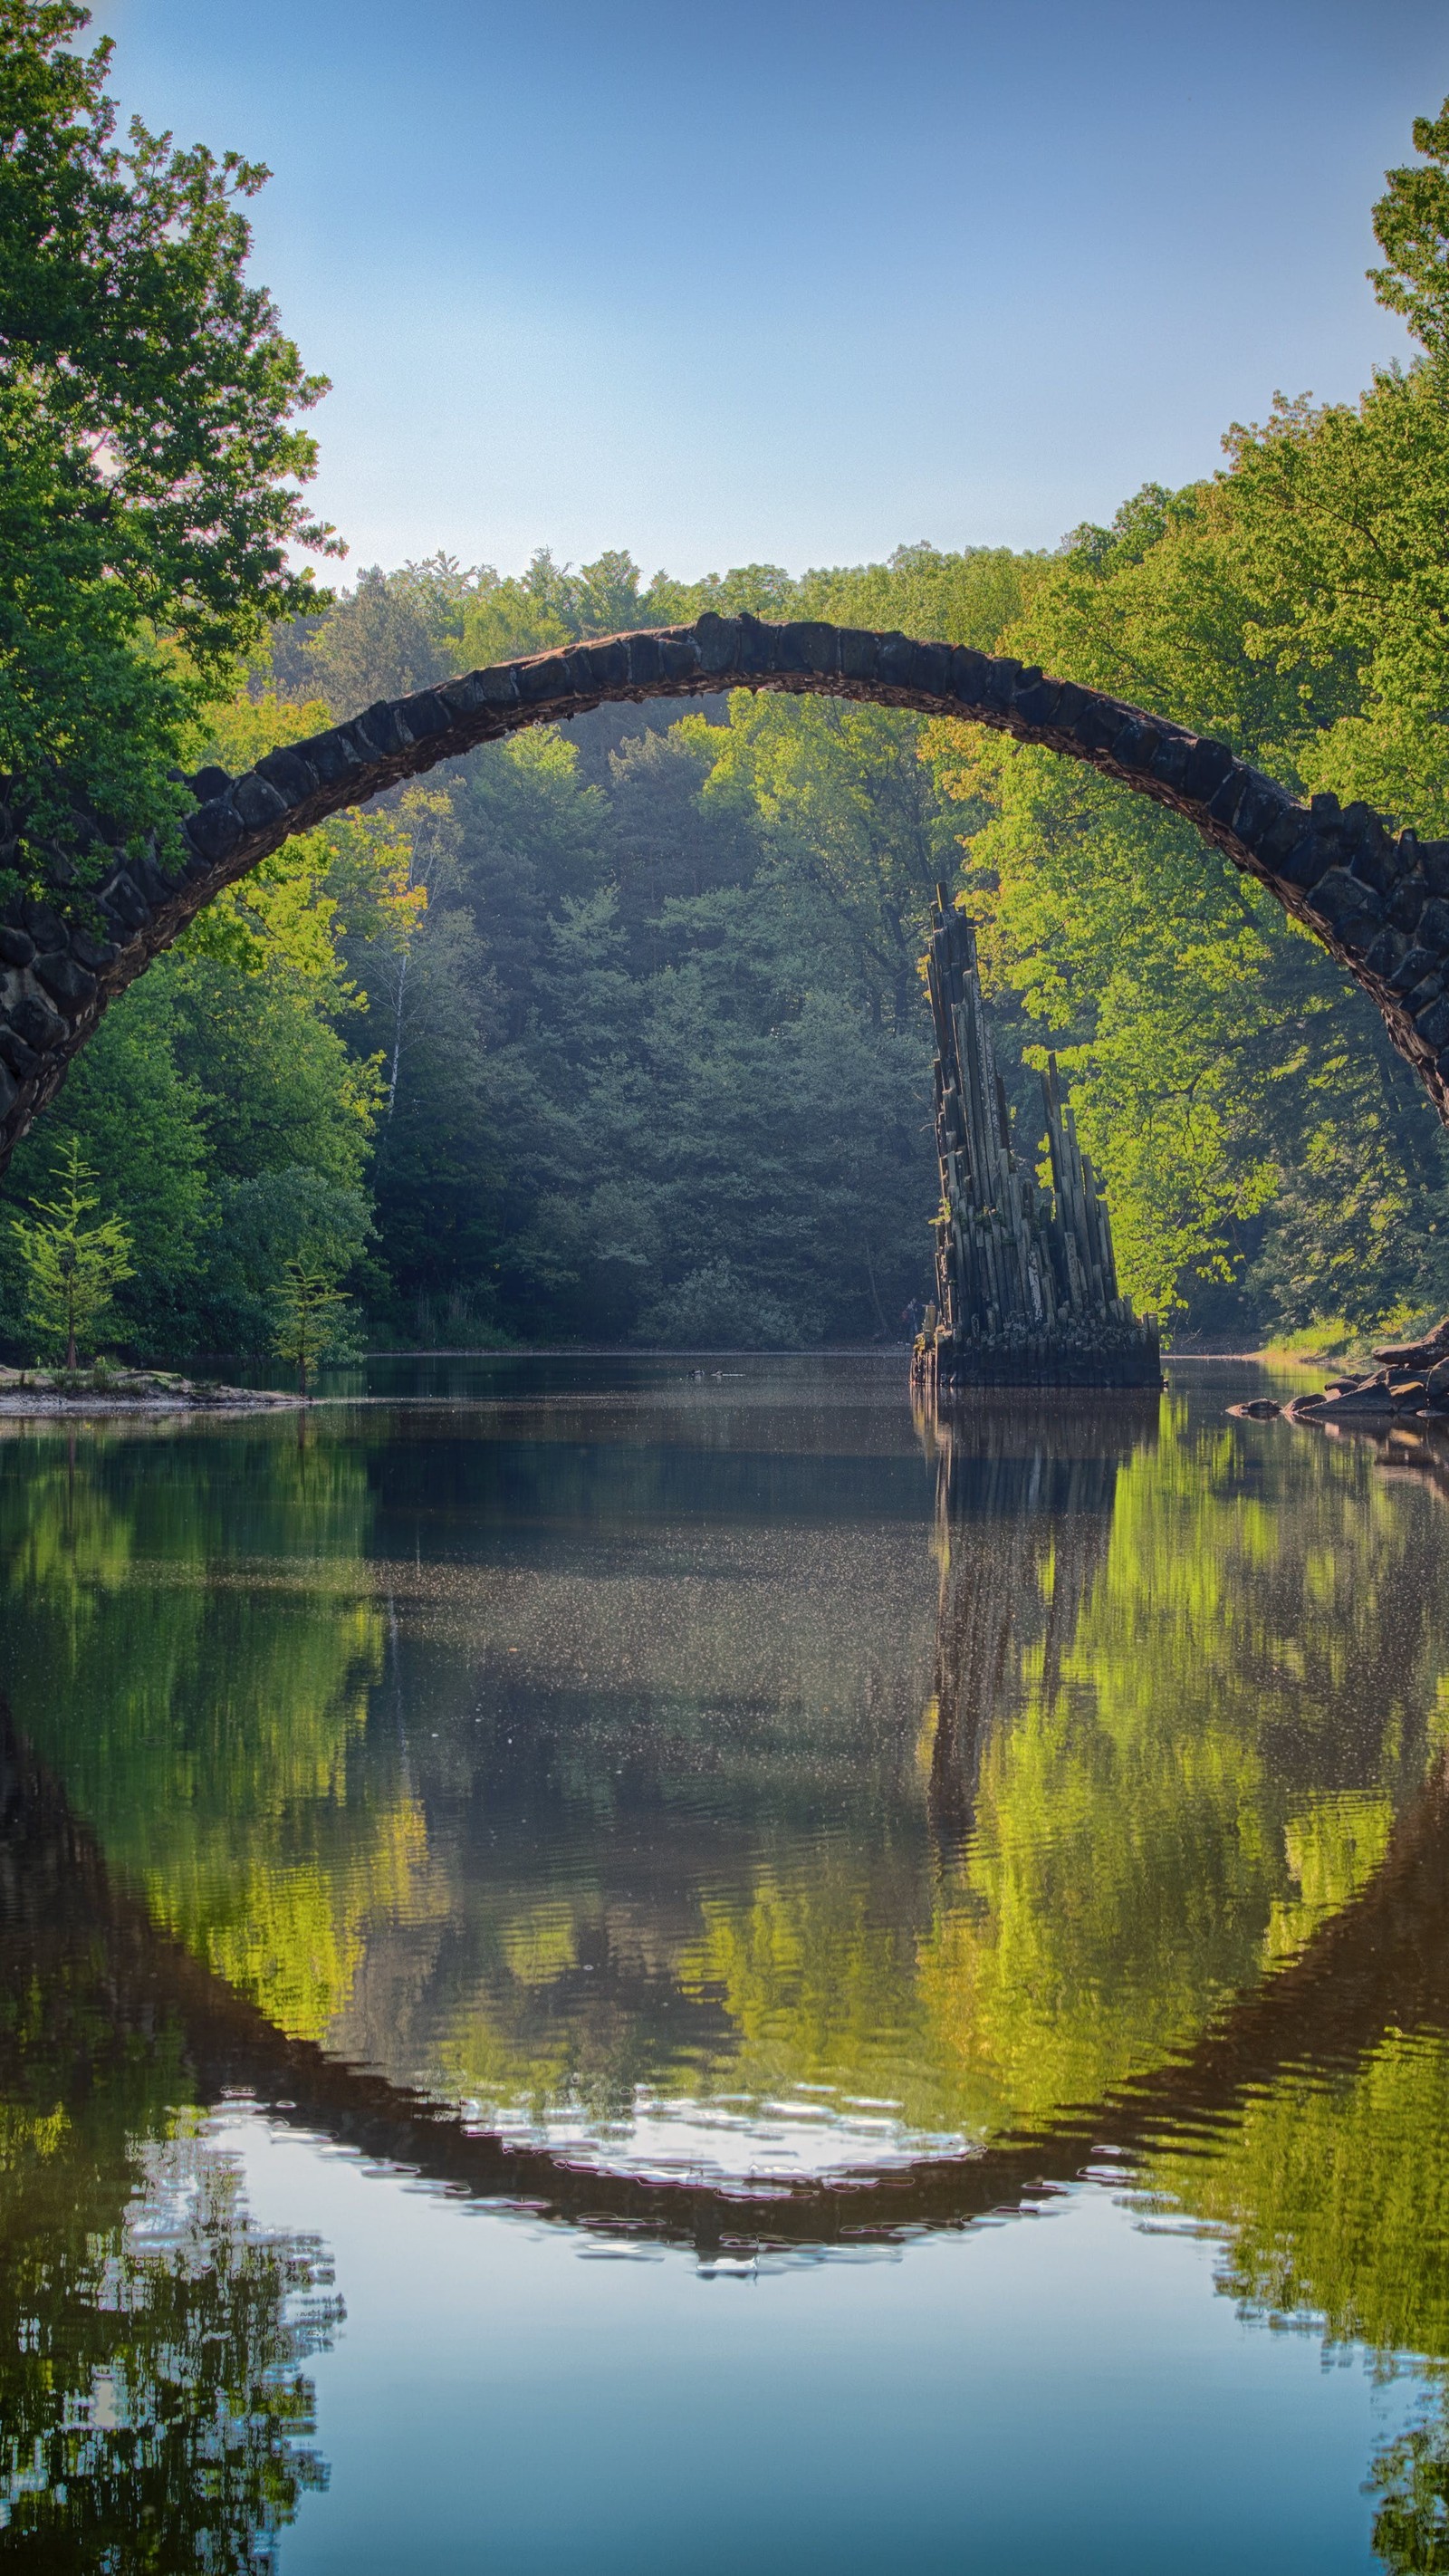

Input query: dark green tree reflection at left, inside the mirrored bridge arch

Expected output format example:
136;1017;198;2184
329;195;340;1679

0;1425;422;2033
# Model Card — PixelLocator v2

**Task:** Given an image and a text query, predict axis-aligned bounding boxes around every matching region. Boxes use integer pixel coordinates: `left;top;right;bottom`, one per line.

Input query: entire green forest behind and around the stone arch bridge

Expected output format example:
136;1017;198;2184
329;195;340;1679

0;8;1449;1358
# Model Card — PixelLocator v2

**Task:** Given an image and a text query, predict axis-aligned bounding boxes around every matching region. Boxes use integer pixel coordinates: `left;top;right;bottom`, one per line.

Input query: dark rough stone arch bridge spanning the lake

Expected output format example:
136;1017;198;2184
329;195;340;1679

0;613;1449;1169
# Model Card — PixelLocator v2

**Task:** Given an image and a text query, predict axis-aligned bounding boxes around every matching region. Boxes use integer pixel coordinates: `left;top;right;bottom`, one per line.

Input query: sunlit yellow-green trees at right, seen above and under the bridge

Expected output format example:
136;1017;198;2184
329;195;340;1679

926;91;1449;1331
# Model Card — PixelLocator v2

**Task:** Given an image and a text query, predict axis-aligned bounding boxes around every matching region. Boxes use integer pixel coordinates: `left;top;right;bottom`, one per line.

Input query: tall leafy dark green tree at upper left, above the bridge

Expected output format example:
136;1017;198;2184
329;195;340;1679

0;0;337;876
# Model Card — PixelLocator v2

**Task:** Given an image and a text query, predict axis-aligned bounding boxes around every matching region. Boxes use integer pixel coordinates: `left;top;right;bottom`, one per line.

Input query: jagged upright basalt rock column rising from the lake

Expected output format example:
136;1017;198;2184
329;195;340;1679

914;886;1161;1401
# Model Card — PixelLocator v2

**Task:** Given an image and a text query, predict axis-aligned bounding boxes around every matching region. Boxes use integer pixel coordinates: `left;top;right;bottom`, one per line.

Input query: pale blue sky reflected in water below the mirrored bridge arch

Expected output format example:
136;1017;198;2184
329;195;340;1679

229;2120;1415;2576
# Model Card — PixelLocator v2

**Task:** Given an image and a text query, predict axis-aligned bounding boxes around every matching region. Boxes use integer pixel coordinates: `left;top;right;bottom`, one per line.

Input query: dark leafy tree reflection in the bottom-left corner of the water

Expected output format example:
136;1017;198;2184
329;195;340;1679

0;1728;342;2571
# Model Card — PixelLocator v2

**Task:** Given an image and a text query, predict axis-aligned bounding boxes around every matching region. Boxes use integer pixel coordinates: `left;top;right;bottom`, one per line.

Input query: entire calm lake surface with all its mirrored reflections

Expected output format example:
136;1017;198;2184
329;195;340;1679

0;1355;1449;2576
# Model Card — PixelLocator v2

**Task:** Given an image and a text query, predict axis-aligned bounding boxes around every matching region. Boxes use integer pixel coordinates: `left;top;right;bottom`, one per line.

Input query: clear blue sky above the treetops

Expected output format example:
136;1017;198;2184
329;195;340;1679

95;0;1449;574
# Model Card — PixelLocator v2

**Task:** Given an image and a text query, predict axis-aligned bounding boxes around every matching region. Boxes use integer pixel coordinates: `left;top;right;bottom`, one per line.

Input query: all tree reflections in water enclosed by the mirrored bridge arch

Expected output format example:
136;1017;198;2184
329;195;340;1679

14;1399;1444;2139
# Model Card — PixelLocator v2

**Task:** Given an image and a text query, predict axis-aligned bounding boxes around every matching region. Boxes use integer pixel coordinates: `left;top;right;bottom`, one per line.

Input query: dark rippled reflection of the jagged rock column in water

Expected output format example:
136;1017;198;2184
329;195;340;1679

919;1396;1158;1860
